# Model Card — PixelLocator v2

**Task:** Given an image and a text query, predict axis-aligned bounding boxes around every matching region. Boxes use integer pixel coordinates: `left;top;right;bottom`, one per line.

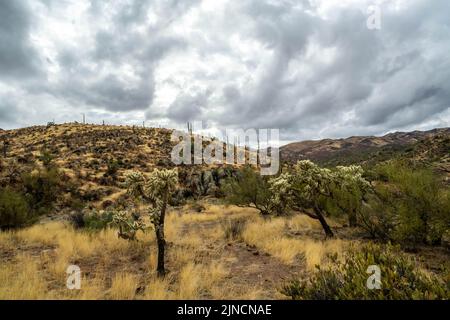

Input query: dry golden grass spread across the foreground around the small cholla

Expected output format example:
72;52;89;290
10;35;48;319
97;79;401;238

0;204;354;299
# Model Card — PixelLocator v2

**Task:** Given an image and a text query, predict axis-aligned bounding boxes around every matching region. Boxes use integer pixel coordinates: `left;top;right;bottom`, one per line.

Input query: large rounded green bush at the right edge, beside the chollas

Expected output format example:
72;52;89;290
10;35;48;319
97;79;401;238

362;162;450;245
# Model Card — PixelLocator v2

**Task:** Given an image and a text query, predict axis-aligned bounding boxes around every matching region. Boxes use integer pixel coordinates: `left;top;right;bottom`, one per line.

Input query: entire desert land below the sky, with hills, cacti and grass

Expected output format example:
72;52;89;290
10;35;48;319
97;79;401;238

0;123;450;299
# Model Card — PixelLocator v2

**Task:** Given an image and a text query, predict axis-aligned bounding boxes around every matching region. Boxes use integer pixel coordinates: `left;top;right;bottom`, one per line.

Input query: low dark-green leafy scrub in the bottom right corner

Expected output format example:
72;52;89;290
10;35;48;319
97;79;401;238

282;244;450;300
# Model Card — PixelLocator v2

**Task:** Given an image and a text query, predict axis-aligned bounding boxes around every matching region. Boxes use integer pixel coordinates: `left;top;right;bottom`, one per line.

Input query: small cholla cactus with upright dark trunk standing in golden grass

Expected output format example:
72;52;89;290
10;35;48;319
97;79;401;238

126;169;178;276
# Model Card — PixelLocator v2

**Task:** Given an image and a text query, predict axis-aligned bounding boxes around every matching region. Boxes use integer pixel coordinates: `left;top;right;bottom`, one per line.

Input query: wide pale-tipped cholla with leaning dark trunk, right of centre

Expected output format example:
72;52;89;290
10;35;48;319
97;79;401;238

269;160;334;237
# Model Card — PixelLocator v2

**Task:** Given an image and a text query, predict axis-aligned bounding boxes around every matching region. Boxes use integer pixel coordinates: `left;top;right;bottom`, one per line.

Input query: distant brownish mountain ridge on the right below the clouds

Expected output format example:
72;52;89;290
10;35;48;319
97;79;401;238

280;128;450;169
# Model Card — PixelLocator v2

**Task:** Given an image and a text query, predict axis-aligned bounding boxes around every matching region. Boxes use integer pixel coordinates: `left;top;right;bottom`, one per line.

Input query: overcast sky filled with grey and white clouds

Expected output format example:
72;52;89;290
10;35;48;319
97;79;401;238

0;0;450;141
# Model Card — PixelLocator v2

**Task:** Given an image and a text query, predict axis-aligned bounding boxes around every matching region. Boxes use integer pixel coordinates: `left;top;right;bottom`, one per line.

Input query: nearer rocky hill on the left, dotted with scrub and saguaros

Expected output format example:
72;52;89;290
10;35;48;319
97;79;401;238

0;123;239;207
